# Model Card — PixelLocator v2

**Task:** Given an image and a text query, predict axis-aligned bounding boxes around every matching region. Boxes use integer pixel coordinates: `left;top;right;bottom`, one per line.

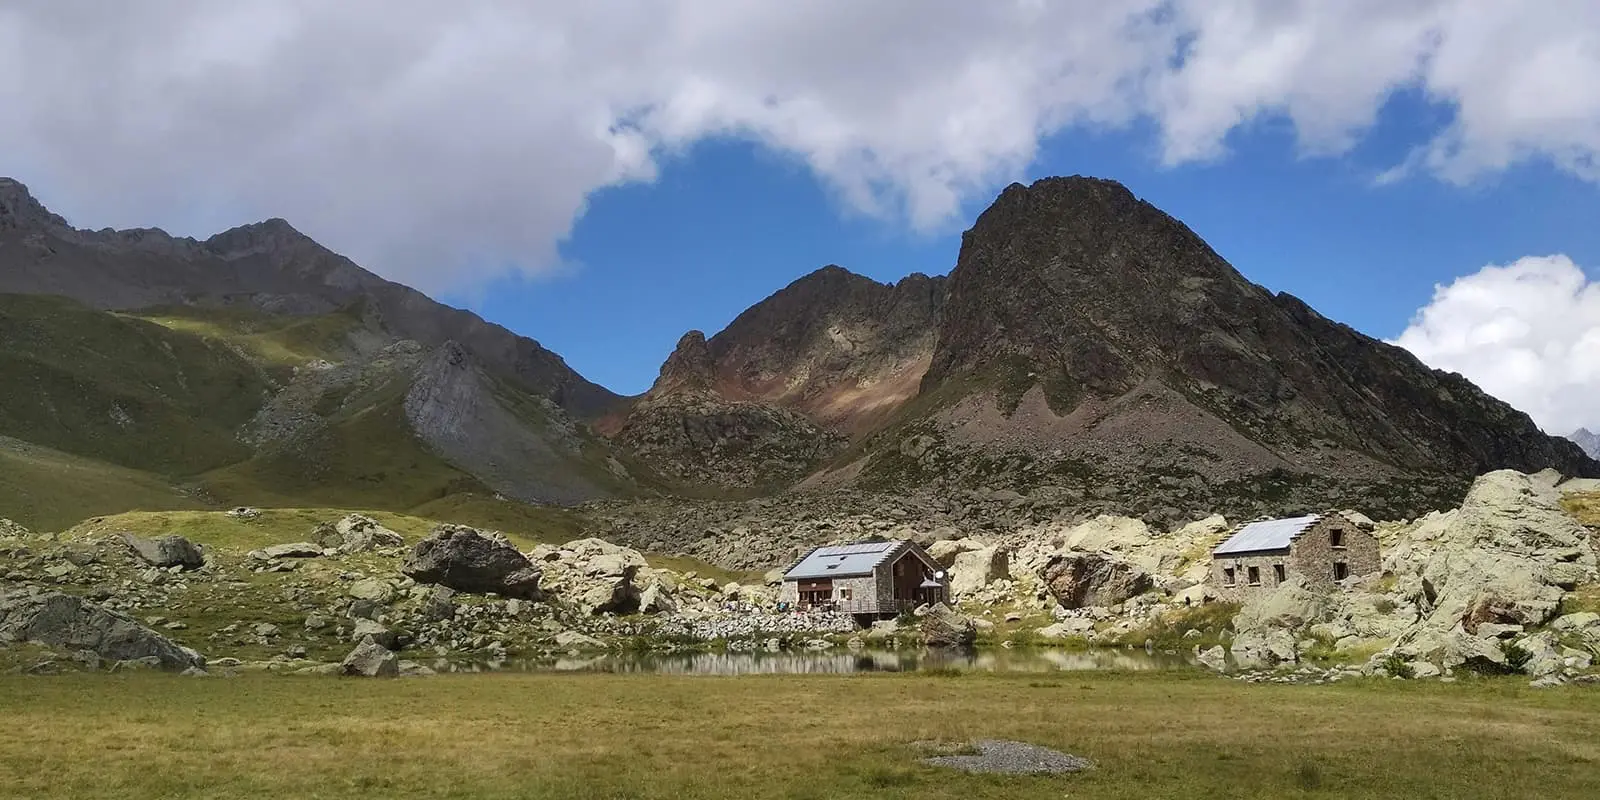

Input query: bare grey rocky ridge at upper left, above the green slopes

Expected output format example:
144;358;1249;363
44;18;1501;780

0;178;622;419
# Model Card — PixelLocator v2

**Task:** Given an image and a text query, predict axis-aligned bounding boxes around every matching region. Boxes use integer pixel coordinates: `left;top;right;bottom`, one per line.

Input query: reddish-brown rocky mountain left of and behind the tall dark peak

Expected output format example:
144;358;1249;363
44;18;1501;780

604;266;944;490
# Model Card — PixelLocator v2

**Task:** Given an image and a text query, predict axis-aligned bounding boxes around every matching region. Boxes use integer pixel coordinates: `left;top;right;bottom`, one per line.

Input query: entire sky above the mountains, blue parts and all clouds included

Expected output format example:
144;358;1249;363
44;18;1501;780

0;0;1600;434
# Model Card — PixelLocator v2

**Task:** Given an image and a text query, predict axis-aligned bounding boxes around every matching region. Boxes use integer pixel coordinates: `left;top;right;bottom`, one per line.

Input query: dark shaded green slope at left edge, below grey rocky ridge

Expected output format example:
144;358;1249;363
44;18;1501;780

0;294;269;475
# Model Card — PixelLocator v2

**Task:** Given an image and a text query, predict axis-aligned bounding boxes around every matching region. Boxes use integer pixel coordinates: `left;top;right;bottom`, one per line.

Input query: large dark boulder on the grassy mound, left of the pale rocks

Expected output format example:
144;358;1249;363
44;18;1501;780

400;525;542;600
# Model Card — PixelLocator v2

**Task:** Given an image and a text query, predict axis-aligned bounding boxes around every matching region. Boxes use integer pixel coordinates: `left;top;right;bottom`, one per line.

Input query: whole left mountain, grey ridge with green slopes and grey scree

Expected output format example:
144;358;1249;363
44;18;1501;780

0;179;638;507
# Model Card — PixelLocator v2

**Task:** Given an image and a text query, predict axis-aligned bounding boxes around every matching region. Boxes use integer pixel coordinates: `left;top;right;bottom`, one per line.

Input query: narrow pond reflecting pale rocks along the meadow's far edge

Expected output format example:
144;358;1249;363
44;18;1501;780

435;650;1192;675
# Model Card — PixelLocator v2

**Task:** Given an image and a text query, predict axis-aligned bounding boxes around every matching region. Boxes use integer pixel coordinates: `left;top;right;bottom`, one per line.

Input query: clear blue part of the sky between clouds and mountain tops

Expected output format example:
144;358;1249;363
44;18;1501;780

446;96;1600;400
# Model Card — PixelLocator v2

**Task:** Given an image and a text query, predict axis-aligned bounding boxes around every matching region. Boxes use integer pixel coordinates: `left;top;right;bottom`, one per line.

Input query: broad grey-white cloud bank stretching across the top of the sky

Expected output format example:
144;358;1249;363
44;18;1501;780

0;0;1600;288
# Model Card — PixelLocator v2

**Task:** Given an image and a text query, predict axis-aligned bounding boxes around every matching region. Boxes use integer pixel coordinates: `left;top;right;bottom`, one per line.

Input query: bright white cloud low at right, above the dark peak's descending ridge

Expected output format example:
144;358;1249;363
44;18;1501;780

1395;256;1600;435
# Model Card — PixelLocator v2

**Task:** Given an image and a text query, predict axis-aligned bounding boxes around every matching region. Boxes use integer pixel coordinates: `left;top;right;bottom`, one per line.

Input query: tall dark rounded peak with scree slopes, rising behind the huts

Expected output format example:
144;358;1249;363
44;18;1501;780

813;178;1600;510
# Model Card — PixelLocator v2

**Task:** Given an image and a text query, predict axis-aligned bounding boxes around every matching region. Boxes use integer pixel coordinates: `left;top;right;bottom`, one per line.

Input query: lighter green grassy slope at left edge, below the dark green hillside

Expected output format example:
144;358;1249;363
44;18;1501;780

0;438;205;531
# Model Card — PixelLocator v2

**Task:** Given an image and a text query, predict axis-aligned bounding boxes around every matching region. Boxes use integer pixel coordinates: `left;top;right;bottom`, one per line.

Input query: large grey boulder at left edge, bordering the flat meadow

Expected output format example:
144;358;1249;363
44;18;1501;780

0;592;205;670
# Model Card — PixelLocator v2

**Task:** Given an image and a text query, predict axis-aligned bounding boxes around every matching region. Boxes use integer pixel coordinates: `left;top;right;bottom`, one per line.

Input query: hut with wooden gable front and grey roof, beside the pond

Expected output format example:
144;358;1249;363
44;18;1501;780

778;539;950;616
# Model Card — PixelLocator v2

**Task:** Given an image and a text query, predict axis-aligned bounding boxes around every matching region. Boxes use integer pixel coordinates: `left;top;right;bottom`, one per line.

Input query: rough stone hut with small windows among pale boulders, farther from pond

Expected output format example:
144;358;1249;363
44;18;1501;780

1211;514;1382;597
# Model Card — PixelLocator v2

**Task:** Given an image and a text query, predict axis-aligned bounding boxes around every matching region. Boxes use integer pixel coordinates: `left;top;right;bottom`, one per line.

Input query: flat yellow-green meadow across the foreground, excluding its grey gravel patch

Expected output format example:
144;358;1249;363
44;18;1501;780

0;674;1600;800
